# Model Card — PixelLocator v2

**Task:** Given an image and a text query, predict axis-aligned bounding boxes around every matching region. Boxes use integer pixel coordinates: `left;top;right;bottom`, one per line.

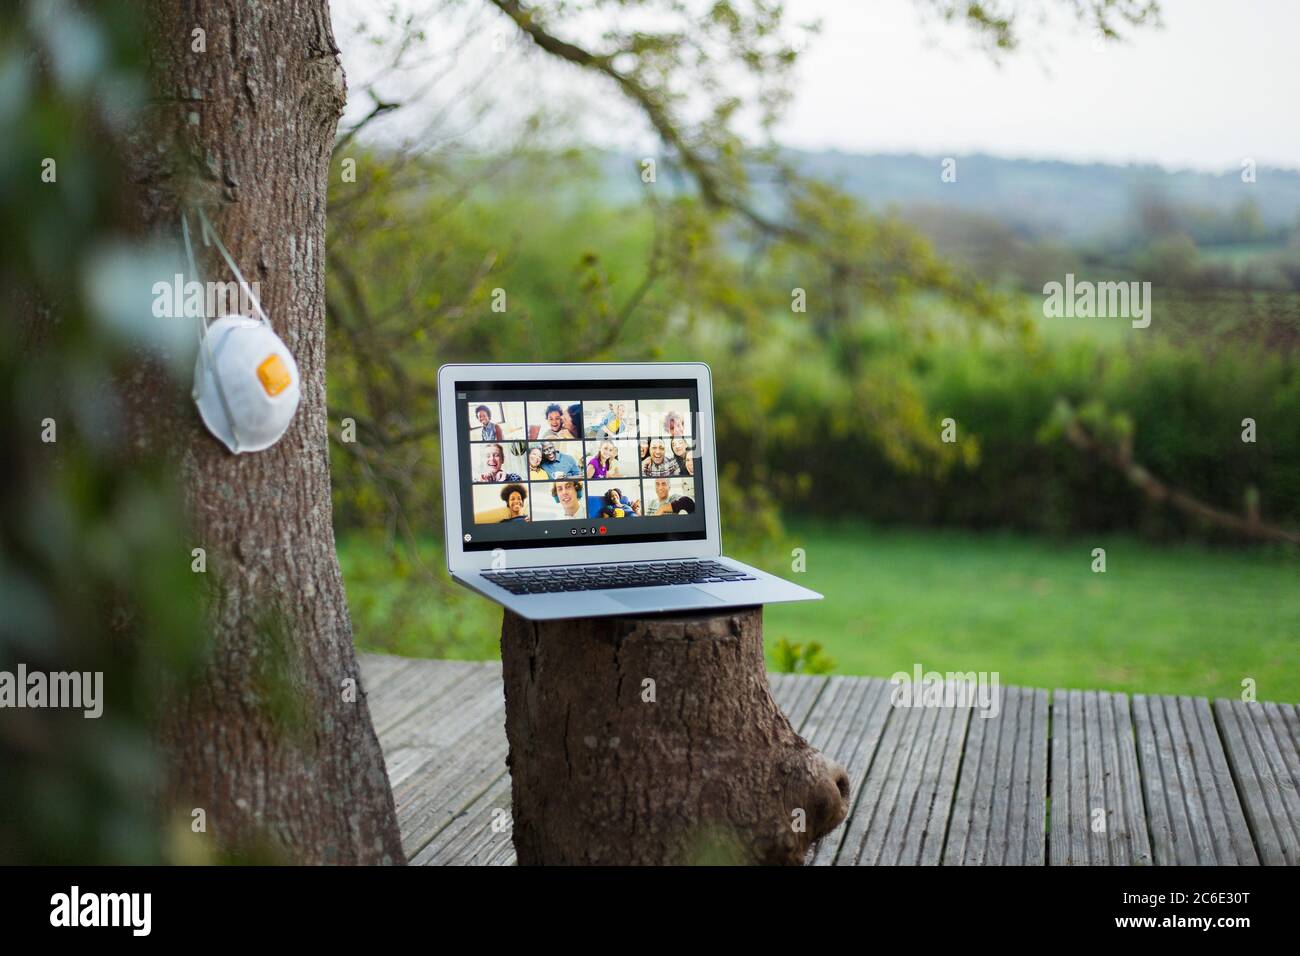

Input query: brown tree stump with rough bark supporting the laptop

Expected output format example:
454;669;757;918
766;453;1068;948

501;607;849;865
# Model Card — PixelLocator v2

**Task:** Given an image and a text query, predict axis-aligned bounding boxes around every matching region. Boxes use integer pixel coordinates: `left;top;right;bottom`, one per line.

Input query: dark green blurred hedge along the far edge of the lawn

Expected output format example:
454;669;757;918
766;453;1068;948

719;342;1300;540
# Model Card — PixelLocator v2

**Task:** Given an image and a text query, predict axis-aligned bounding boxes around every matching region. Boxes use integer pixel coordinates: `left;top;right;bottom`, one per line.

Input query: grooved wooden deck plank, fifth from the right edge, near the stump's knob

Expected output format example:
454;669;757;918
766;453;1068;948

836;681;971;866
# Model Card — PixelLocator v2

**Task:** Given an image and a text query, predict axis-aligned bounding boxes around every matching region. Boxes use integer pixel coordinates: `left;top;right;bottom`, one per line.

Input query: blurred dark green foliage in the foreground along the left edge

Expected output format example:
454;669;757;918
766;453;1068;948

0;3;204;865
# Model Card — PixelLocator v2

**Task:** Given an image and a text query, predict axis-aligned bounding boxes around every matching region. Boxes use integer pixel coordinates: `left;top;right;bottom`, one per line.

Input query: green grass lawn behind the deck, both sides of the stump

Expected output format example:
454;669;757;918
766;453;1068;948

339;523;1300;701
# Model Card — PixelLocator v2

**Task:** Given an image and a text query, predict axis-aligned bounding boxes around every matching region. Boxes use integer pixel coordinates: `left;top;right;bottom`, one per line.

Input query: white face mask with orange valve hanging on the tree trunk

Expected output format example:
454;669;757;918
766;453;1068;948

181;209;302;455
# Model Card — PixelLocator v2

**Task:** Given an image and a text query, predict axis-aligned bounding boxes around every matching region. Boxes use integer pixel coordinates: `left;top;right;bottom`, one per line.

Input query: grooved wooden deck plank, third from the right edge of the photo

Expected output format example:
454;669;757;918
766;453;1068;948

1049;689;1152;866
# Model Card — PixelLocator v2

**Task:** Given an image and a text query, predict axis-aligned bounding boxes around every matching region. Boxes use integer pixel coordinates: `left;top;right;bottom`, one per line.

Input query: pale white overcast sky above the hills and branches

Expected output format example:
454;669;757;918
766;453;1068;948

334;0;1300;170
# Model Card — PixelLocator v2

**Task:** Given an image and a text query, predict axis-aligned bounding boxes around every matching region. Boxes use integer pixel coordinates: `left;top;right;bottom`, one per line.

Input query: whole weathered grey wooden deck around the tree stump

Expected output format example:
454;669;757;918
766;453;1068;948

361;654;1300;866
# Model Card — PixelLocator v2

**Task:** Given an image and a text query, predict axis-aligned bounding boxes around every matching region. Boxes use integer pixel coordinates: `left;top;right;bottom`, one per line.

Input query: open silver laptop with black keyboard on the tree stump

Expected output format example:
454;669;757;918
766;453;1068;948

438;363;822;620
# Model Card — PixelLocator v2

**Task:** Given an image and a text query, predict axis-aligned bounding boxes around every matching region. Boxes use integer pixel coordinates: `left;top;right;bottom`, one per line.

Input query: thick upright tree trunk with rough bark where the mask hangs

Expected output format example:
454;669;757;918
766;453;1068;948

134;0;404;864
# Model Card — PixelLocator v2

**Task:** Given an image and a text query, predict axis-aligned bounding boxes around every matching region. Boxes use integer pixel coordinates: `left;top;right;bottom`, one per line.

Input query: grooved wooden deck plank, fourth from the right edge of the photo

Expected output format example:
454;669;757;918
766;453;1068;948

944;687;1048;866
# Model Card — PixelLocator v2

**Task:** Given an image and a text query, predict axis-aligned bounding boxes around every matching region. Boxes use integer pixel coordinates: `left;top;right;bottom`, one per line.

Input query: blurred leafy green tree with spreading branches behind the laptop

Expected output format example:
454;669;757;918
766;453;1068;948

329;0;1154;541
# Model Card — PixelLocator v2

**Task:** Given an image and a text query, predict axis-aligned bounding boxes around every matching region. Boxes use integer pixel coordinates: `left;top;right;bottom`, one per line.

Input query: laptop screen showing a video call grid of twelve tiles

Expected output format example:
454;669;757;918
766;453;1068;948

447;378;711;551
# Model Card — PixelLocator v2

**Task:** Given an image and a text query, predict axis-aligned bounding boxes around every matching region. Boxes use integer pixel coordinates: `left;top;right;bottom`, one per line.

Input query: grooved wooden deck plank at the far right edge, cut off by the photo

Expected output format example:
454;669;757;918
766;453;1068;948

1214;698;1300;866
